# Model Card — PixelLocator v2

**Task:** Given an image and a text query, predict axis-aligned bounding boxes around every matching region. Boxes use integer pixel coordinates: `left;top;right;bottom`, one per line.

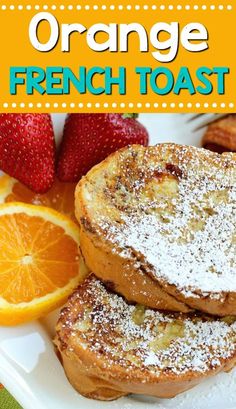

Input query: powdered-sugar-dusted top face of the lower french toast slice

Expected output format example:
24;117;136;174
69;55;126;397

57;275;236;375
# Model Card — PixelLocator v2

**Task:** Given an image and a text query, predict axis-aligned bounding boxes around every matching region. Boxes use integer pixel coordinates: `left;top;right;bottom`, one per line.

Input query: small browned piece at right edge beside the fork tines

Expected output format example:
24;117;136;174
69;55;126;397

202;114;236;153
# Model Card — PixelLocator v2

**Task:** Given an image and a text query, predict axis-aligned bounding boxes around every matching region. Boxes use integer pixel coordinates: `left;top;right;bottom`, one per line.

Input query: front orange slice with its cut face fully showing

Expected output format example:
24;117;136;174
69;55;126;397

0;202;87;325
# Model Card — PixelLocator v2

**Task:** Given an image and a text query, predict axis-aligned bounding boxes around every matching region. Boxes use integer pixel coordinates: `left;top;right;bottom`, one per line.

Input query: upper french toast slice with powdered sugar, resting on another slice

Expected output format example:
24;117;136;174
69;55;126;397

75;144;236;316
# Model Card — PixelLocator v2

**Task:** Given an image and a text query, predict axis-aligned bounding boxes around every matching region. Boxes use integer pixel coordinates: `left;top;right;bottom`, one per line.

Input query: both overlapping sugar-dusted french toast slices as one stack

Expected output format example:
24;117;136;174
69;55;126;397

55;144;236;400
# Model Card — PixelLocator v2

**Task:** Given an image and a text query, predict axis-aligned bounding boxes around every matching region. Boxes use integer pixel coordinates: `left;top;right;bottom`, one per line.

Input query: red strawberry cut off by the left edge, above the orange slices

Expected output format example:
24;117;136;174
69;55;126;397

0;114;55;193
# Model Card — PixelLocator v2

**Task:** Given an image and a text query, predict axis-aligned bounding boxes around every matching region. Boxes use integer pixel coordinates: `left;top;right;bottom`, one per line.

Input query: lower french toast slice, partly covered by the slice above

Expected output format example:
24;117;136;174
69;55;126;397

54;274;236;400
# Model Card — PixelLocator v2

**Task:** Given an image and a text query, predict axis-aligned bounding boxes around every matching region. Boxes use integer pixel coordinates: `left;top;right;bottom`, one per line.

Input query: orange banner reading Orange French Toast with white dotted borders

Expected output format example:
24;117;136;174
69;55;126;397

0;0;236;112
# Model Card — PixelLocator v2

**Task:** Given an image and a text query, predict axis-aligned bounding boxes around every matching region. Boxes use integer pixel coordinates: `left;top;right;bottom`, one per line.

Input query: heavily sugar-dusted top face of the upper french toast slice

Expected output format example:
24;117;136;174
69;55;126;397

95;145;236;299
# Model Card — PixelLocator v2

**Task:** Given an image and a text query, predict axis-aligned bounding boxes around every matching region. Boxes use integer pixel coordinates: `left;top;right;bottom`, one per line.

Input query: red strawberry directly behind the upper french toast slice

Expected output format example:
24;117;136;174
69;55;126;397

57;114;149;182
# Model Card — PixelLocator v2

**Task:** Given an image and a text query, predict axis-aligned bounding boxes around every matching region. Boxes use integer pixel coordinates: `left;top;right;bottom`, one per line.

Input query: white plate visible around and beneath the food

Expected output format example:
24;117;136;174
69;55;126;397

0;114;236;409
